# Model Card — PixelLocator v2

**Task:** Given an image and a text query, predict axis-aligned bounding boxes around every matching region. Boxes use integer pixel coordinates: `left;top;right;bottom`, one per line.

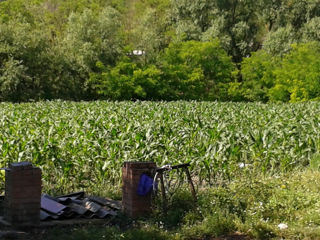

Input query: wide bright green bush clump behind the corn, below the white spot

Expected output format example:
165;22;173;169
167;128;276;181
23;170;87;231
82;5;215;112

89;41;234;100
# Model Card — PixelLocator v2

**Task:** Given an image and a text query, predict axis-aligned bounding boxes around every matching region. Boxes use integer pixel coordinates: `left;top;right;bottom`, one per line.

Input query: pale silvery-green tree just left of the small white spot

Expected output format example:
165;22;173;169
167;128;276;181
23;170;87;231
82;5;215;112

54;7;122;98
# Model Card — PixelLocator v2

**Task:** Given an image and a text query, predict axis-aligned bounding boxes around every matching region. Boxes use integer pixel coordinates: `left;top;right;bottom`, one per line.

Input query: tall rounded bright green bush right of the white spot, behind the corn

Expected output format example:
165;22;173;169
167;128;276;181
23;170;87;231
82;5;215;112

162;40;234;100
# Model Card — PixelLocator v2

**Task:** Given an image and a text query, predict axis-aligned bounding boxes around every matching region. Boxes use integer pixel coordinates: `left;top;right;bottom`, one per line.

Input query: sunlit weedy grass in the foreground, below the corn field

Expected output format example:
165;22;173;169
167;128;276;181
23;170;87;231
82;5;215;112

23;169;320;240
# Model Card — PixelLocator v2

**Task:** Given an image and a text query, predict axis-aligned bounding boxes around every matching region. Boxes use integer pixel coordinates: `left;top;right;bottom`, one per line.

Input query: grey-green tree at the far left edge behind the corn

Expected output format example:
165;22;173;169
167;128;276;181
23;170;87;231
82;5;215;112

0;20;51;101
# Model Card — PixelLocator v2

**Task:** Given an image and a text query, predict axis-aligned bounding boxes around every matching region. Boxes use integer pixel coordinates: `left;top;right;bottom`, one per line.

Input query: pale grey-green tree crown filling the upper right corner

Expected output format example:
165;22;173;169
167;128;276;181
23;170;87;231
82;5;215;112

261;0;320;55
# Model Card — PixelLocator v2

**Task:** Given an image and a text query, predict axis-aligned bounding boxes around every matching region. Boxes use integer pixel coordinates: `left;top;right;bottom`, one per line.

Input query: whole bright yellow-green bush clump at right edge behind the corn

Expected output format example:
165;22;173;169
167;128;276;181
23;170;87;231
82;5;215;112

238;42;320;102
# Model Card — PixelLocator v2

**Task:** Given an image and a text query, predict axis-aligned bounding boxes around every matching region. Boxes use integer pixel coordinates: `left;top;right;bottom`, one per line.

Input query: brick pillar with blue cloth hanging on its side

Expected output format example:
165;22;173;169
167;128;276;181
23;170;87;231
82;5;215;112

122;162;156;218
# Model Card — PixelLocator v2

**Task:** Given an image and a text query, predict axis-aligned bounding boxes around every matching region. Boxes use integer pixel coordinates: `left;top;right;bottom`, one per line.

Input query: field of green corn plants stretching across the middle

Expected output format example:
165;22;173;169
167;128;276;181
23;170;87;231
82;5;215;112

0;101;320;191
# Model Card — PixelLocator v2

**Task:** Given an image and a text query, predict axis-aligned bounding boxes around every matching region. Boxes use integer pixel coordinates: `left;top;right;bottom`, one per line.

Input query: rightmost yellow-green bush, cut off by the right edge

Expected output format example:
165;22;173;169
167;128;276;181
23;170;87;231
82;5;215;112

269;42;320;102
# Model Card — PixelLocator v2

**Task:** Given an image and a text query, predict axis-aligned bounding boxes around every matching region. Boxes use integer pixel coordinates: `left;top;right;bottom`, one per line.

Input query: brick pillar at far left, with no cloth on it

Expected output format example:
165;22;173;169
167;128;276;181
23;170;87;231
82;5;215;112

4;162;41;227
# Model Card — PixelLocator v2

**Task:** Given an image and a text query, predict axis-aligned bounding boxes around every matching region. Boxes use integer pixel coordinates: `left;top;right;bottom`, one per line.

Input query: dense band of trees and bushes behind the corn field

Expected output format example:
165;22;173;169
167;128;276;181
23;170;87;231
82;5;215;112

0;0;320;102
